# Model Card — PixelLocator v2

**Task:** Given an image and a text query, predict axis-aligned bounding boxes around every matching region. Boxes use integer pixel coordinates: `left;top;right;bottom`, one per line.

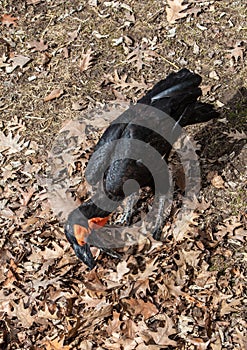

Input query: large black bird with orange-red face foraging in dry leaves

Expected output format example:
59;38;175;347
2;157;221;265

65;68;218;269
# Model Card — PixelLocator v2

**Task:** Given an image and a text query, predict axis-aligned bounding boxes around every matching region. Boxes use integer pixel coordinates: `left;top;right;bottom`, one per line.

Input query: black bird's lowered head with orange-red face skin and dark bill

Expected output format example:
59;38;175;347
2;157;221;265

64;206;108;270
